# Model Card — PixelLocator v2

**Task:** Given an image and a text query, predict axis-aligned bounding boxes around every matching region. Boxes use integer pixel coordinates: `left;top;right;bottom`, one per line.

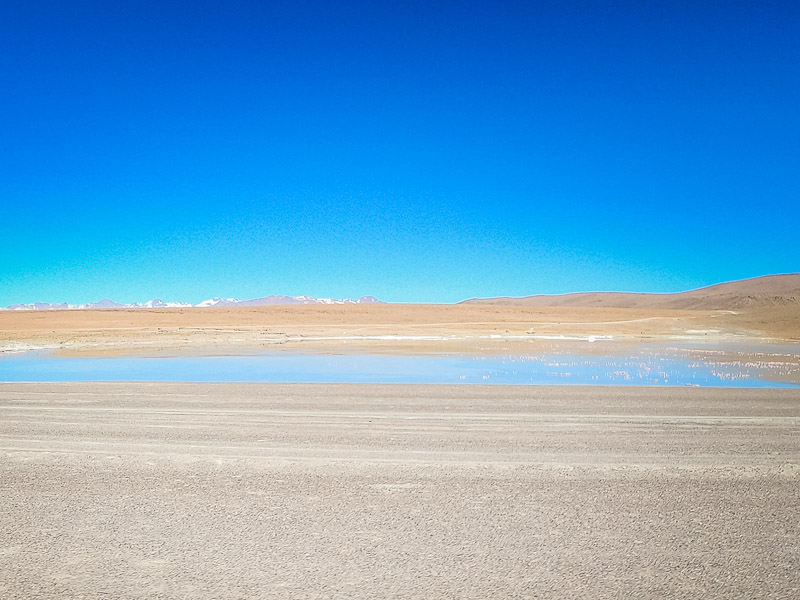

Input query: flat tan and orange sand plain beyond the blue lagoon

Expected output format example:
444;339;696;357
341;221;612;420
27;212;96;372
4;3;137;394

0;304;800;355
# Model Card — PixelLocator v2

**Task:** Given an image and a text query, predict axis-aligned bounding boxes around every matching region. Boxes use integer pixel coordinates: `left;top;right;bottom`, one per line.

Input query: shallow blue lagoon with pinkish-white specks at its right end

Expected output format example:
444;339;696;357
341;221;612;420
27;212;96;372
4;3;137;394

0;347;800;387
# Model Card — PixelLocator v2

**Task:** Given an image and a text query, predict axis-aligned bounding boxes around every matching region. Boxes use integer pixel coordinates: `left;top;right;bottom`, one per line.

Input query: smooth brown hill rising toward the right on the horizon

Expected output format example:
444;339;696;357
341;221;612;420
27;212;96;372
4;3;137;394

463;273;800;311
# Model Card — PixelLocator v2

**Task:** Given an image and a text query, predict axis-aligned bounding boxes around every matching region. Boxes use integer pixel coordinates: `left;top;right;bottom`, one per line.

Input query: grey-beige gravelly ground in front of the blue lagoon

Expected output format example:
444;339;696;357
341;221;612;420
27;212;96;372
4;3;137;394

0;383;800;599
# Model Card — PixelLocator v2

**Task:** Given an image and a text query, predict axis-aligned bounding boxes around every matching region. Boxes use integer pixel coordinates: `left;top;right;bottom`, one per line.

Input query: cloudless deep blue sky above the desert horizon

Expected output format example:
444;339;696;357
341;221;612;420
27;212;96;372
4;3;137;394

0;0;800;306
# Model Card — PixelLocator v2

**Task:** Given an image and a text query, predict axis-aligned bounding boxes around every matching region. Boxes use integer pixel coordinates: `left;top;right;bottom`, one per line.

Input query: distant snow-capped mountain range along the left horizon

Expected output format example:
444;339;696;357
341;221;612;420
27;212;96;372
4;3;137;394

0;296;383;310
